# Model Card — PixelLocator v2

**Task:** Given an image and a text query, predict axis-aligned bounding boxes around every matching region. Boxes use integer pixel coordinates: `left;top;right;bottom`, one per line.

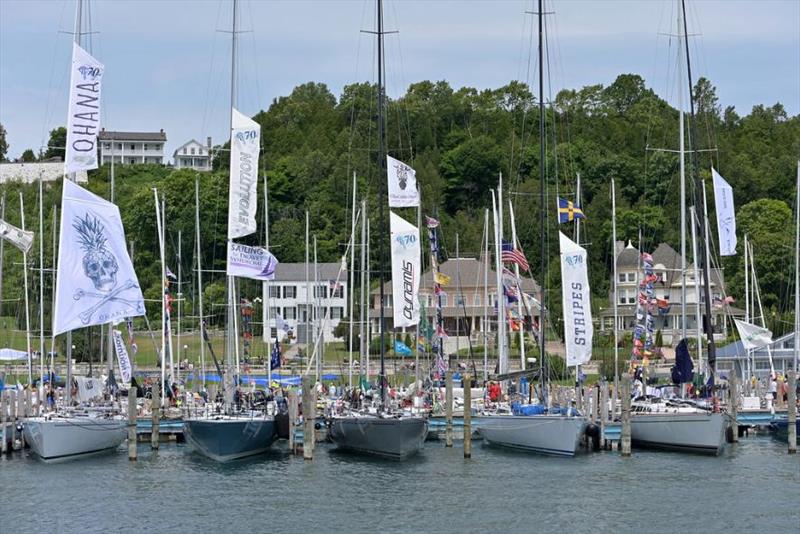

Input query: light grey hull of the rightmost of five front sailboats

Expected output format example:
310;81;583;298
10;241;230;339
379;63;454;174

631;413;726;455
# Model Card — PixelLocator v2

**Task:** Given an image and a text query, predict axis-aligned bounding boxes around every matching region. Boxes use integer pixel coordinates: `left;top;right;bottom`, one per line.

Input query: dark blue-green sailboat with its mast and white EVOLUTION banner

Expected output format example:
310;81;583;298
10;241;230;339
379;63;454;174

183;0;277;462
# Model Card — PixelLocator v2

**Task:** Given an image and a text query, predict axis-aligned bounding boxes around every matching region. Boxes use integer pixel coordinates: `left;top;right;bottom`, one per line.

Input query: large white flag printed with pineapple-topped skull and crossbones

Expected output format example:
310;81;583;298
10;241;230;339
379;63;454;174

53;180;145;336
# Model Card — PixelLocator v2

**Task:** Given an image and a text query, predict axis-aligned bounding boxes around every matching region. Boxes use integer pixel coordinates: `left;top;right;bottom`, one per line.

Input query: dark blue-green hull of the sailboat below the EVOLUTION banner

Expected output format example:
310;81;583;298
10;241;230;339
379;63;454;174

183;416;277;462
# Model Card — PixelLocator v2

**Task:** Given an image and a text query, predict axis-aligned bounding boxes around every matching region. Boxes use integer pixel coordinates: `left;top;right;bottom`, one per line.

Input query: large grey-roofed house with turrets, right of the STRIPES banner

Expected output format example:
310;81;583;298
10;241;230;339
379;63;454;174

599;242;744;346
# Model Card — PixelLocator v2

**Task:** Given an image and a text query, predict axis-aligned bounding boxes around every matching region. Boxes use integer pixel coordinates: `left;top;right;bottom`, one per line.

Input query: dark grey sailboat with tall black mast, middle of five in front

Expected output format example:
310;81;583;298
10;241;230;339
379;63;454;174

328;0;428;460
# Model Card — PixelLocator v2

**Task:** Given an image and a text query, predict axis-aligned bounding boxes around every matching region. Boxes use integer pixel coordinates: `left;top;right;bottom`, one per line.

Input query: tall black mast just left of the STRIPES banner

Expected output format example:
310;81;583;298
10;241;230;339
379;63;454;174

538;0;548;403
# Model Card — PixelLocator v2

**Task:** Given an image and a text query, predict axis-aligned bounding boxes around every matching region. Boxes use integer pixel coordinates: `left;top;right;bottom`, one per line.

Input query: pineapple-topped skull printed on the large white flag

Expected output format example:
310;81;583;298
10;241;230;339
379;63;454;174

72;211;119;293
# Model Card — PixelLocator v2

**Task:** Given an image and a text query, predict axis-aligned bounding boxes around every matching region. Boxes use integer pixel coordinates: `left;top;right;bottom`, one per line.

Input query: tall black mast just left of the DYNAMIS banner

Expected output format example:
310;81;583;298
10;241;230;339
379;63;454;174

377;0;388;405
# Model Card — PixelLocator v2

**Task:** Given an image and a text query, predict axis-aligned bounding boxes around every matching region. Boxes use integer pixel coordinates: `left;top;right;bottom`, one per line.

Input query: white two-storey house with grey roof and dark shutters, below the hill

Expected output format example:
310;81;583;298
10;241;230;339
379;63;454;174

264;263;348;343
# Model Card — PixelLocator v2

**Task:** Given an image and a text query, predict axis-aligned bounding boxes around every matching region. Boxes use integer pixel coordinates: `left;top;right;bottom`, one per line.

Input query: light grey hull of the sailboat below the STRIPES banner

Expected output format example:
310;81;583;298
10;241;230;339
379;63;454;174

478;415;586;456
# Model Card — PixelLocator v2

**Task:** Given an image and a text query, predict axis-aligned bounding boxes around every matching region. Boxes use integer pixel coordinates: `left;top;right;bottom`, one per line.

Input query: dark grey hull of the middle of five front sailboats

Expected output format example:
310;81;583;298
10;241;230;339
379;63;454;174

328;416;428;460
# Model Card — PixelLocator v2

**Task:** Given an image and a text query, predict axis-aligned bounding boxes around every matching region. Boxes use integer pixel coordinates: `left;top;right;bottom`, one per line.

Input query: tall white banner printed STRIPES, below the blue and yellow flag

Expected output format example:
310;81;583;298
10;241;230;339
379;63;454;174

559;232;594;366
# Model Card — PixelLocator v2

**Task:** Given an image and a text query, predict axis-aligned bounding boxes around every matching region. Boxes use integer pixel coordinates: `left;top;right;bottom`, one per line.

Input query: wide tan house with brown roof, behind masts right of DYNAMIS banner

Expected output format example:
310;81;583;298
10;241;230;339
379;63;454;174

370;258;539;352
